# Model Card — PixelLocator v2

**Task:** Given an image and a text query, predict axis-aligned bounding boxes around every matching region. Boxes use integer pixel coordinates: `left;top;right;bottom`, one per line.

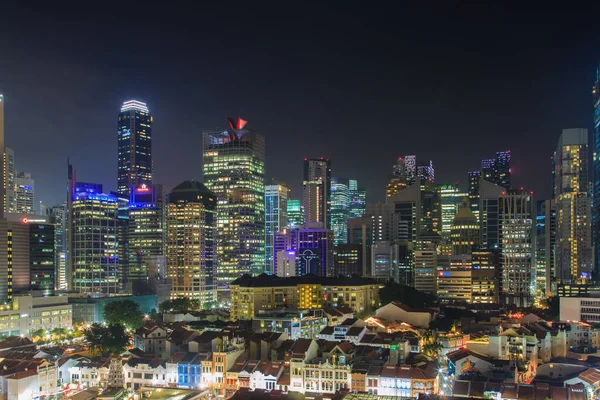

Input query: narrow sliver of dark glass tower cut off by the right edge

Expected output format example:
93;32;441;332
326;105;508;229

592;67;600;274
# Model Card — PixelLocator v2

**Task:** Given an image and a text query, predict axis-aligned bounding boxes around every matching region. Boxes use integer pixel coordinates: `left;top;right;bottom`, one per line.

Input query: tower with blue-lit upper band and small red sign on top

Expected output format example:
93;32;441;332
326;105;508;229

128;184;166;293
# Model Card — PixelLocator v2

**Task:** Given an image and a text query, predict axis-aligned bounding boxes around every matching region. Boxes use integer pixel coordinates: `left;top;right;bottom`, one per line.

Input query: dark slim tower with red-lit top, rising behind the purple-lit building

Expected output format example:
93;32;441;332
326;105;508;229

302;158;331;229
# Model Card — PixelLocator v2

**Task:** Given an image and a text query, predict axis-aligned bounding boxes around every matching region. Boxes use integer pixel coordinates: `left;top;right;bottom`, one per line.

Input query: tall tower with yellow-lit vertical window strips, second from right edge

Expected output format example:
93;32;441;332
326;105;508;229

554;129;593;283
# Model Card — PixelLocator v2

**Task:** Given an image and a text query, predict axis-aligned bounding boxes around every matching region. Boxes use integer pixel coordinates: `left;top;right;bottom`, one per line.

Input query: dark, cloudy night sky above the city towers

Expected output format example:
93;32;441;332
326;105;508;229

0;1;600;205
